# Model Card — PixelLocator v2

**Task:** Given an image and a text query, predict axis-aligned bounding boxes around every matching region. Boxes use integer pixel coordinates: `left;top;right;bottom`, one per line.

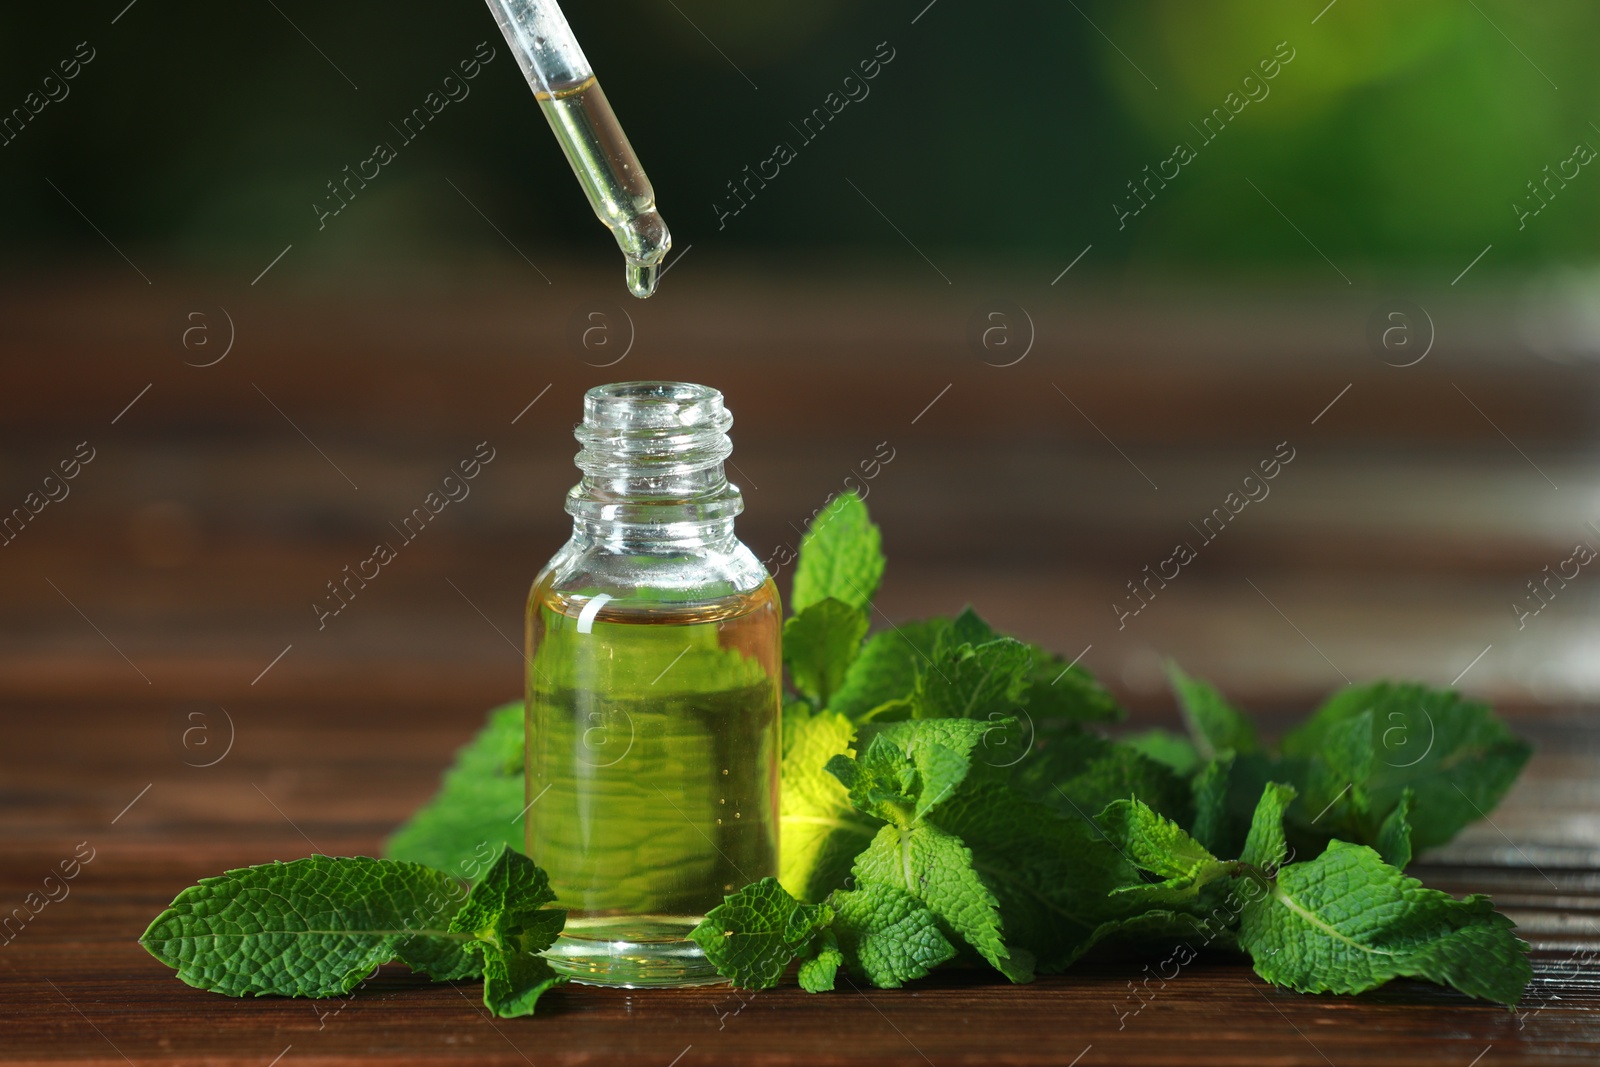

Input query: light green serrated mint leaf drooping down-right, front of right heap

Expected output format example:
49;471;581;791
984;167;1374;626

854;822;1034;982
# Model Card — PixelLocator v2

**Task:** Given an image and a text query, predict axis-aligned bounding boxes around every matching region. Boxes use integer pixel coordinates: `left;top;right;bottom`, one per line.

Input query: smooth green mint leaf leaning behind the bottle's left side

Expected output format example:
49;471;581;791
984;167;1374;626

384;702;528;881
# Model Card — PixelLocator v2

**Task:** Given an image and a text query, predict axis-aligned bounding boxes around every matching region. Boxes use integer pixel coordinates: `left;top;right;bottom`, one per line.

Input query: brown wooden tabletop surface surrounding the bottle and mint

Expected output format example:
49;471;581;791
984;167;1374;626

0;267;1600;1067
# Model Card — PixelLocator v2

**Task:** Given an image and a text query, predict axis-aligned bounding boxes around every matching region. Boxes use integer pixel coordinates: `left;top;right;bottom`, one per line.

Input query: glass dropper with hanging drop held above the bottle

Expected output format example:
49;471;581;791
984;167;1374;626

488;0;672;299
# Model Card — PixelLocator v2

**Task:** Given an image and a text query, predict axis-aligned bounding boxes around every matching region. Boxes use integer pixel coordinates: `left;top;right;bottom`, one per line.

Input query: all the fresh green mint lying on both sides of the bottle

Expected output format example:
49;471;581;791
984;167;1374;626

142;494;1531;1016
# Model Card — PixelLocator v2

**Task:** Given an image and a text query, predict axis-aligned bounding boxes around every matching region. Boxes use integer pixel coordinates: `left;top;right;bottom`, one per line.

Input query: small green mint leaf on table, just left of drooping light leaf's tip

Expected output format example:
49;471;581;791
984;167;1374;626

832;883;955;989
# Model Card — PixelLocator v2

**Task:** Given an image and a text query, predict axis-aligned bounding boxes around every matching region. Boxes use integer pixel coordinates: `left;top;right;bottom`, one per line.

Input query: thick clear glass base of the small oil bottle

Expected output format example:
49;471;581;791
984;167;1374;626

544;915;728;989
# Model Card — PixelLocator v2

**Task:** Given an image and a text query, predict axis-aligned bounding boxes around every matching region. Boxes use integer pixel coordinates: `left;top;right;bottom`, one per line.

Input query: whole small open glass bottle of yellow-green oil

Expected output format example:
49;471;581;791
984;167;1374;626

526;382;782;987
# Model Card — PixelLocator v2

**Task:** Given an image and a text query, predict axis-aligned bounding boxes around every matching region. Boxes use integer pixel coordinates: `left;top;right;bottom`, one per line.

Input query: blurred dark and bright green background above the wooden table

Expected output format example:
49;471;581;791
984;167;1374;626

0;0;1600;277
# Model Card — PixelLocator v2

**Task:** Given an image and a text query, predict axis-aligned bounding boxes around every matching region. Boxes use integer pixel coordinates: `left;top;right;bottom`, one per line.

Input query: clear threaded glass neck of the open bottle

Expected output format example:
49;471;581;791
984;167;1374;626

566;382;744;552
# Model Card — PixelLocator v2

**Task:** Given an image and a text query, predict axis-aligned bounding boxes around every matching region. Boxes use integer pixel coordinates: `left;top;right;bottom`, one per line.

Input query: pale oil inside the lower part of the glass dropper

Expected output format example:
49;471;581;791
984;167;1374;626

538;75;672;298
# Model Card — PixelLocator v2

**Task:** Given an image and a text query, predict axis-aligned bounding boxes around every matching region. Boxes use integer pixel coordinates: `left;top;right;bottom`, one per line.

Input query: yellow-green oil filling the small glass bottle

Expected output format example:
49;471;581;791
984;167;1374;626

526;579;781;985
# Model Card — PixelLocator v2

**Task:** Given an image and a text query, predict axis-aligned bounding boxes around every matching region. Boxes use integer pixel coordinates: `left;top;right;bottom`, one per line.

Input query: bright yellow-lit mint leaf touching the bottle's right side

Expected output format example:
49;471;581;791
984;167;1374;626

778;704;878;904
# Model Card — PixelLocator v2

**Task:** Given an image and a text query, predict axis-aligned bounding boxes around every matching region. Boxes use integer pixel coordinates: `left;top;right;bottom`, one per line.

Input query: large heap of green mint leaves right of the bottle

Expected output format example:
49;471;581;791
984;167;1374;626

701;498;1528;1003
